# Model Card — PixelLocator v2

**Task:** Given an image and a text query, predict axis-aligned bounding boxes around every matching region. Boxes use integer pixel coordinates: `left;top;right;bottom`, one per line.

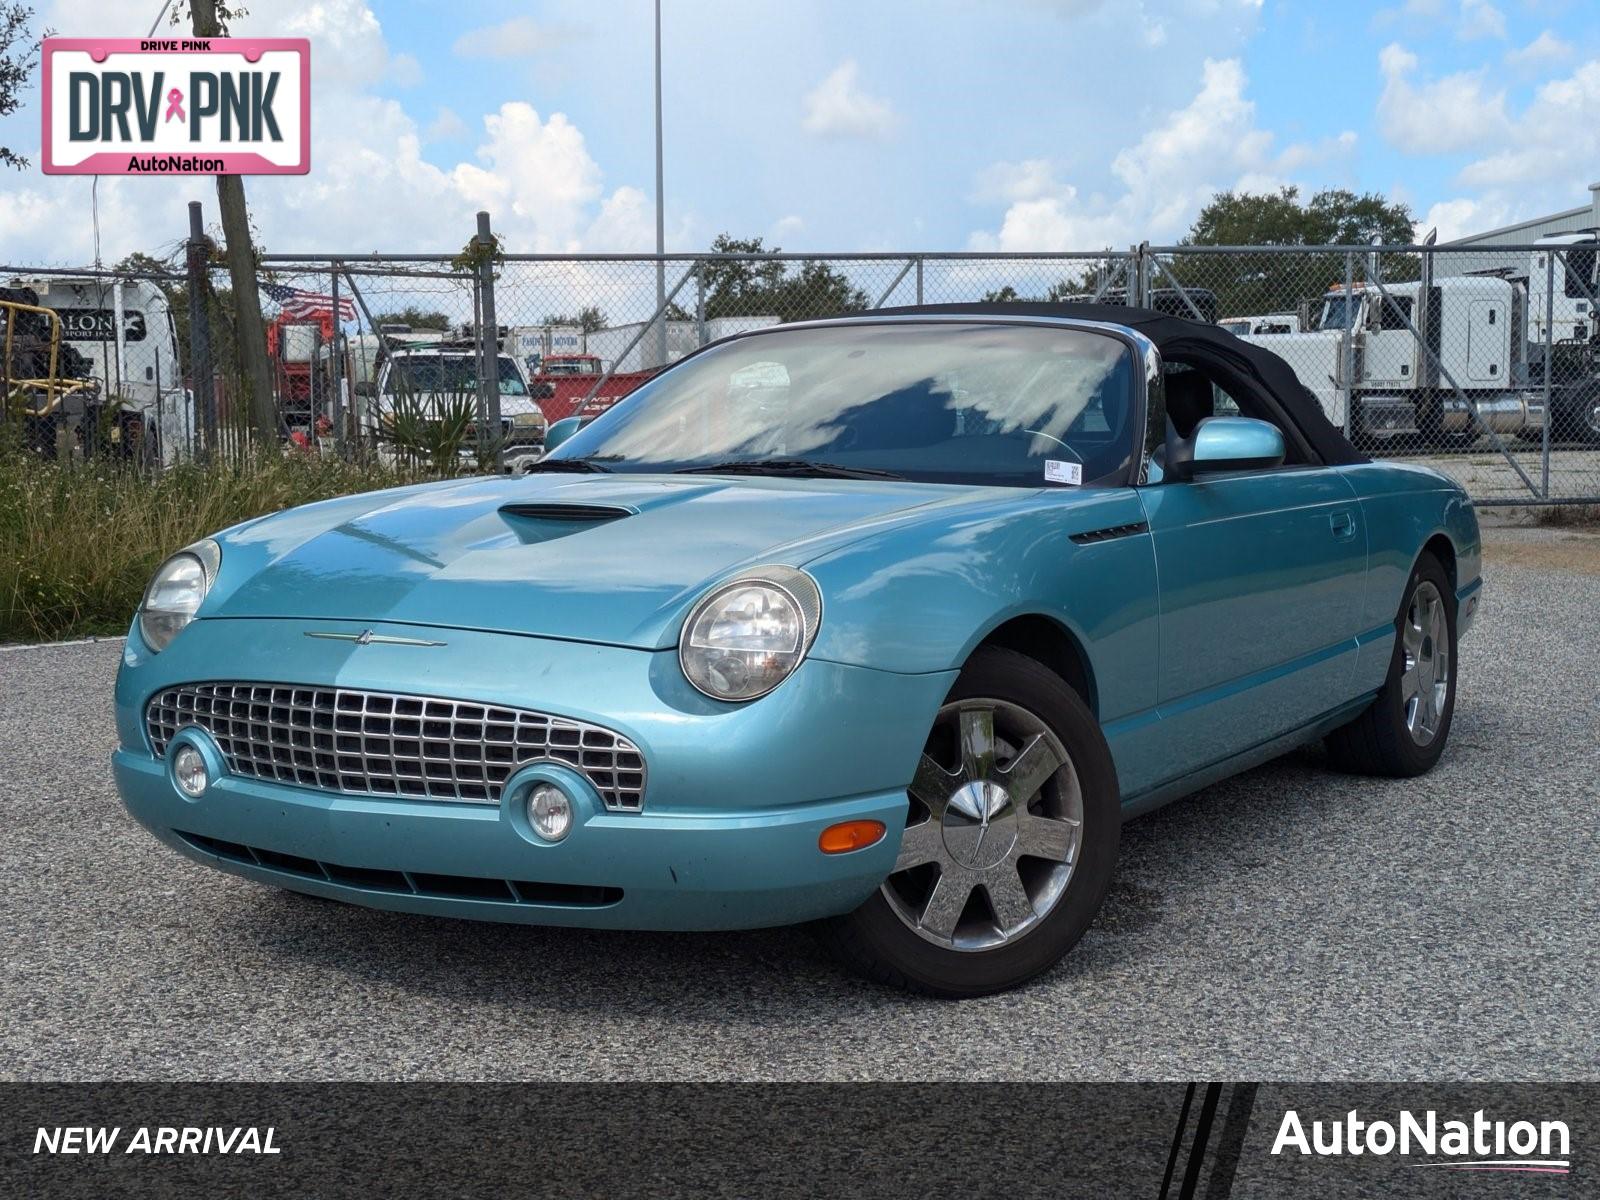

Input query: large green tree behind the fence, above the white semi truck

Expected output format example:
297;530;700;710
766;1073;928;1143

1155;187;1418;317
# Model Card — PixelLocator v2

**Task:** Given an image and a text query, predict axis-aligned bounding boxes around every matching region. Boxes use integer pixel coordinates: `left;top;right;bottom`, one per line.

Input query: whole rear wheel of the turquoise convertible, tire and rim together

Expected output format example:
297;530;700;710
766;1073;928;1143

1326;554;1456;778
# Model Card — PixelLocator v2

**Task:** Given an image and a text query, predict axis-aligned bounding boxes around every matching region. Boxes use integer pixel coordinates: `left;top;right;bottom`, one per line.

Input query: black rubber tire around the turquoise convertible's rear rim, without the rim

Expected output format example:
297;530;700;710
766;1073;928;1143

1326;552;1458;779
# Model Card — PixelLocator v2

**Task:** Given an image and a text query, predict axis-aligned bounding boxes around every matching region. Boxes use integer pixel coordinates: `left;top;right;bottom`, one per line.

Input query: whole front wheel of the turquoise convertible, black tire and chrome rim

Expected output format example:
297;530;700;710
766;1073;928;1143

826;648;1122;997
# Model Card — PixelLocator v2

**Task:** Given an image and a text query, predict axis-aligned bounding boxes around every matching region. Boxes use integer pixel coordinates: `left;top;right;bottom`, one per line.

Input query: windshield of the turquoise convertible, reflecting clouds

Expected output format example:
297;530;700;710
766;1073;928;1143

552;323;1136;488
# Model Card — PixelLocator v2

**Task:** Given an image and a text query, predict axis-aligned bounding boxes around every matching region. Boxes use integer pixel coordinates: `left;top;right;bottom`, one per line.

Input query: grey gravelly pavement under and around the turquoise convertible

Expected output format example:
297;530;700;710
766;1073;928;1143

0;530;1600;1080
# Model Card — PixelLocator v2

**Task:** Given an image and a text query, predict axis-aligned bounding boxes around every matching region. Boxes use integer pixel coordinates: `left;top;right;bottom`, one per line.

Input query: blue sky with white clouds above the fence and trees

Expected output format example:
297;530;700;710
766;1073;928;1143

0;0;1600;262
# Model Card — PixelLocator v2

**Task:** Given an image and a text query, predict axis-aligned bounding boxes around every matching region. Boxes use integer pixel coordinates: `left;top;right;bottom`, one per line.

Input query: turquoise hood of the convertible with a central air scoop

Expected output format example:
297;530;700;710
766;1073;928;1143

202;475;992;650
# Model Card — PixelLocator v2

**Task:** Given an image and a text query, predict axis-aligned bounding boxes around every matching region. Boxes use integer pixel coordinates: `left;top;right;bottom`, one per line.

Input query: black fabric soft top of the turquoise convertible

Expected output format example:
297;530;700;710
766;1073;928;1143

851;301;1368;466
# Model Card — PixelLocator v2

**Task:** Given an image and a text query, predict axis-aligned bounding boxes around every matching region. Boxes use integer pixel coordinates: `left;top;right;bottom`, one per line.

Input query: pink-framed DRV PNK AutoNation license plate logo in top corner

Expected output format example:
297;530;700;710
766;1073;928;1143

43;37;310;174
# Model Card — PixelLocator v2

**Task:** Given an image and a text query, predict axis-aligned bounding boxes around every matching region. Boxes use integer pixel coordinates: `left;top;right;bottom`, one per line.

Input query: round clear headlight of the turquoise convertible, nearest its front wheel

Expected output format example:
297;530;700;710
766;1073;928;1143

678;566;822;701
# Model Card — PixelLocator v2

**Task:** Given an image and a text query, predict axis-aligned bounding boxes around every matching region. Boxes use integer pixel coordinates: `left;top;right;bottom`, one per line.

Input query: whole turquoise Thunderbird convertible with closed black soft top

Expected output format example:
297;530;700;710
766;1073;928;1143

115;304;1480;995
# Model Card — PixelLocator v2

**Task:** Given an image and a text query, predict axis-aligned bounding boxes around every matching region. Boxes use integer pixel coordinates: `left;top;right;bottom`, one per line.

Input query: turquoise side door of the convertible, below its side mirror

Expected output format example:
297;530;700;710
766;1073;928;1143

1141;376;1366;790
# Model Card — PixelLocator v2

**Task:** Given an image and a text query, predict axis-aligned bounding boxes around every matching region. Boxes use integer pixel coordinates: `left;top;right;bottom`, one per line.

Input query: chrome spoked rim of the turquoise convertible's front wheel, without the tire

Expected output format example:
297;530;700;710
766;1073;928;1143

883;699;1083;950
